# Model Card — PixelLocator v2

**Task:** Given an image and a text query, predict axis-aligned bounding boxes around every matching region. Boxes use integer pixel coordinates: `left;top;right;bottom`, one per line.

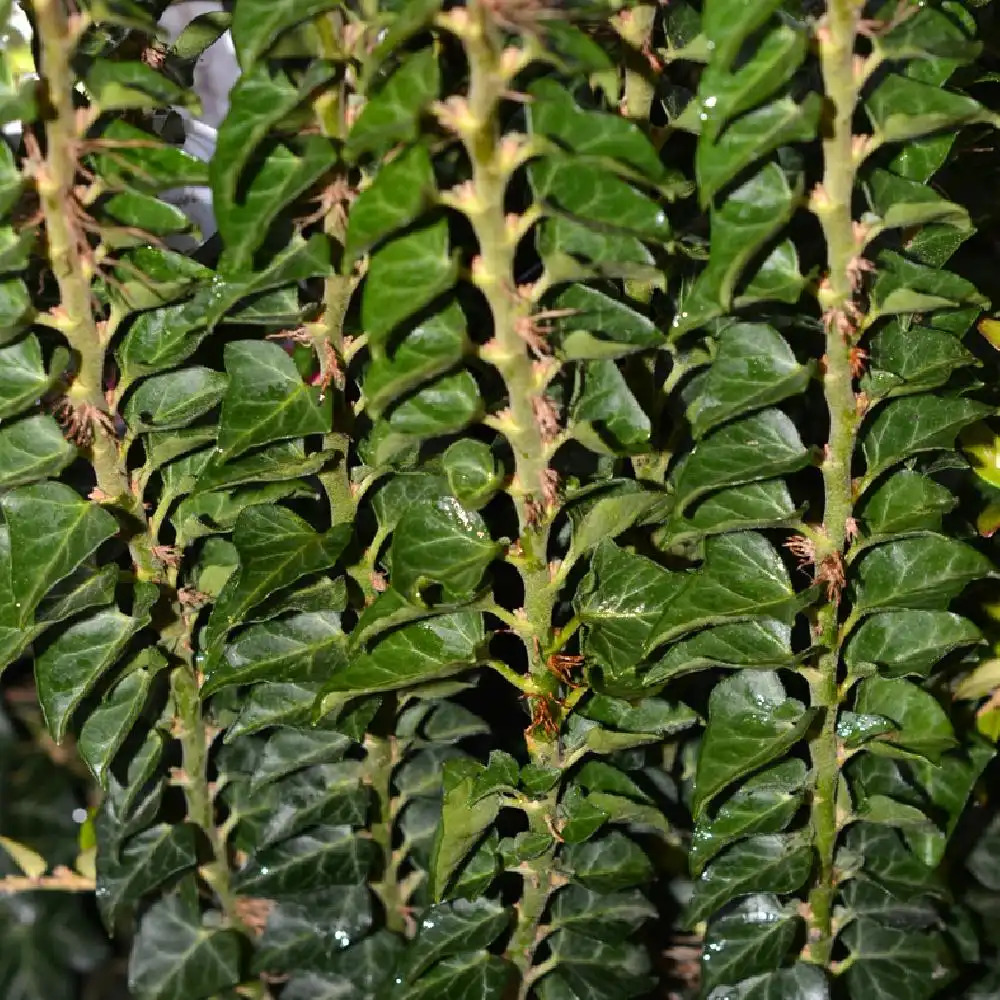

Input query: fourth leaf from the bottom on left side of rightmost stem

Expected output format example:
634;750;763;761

688;757;807;875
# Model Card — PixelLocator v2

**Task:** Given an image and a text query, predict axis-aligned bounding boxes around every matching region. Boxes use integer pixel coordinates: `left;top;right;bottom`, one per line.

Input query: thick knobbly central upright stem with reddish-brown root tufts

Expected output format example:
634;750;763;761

458;2;562;984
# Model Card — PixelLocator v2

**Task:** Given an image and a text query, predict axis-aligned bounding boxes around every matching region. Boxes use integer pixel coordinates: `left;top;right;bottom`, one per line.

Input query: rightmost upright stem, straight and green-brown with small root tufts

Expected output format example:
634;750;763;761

809;0;863;965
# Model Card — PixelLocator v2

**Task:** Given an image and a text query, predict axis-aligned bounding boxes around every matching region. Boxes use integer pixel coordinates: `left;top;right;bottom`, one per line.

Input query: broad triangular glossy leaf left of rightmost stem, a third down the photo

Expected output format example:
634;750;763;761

687;323;811;438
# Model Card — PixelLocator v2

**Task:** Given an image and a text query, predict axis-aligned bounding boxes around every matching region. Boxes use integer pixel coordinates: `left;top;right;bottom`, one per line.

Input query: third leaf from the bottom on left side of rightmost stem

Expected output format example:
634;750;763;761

684;834;813;927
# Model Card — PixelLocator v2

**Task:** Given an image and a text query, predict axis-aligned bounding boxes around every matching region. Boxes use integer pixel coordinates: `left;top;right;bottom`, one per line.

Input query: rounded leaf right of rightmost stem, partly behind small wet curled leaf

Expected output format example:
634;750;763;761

854;677;956;763
